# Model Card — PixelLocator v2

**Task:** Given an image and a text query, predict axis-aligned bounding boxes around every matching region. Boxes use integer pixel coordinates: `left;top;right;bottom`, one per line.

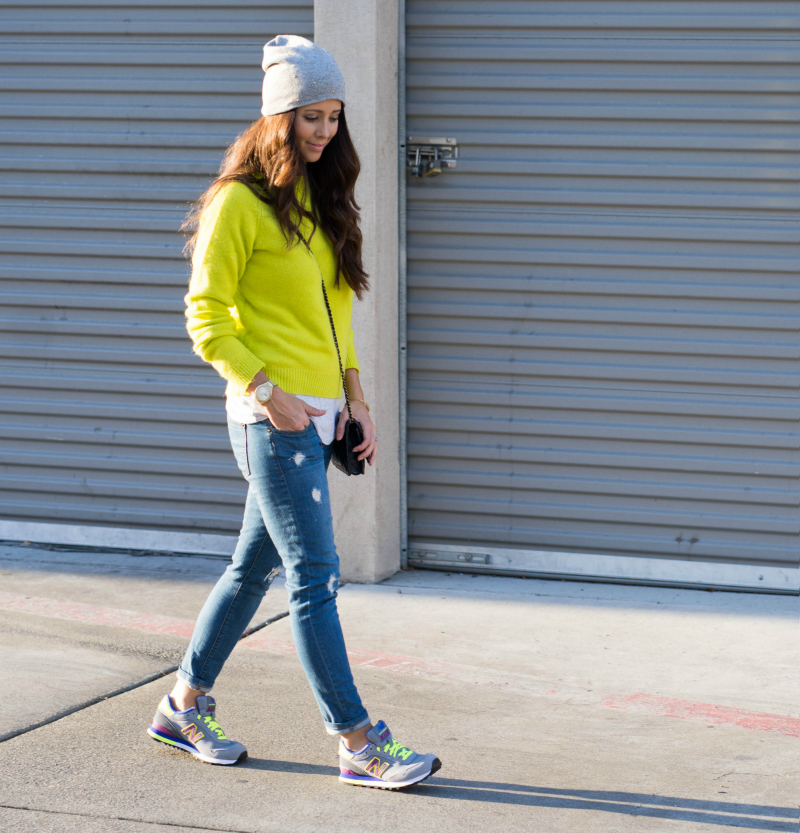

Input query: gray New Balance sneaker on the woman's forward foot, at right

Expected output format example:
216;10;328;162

339;720;442;790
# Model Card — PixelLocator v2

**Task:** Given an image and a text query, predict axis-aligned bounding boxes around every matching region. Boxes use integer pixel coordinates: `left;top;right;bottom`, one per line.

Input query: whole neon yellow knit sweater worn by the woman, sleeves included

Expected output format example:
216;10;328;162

184;182;358;398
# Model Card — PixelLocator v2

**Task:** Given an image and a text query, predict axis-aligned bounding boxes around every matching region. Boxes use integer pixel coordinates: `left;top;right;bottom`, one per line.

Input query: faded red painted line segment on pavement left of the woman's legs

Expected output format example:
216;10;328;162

0;593;194;638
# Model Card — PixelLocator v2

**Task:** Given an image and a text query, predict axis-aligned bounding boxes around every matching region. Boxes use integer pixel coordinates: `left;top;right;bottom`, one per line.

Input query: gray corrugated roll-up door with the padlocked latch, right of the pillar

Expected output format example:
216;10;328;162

406;0;800;591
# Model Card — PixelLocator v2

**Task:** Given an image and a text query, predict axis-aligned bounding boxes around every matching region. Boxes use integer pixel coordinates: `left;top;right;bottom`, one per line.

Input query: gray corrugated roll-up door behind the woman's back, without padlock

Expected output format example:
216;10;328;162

0;0;313;537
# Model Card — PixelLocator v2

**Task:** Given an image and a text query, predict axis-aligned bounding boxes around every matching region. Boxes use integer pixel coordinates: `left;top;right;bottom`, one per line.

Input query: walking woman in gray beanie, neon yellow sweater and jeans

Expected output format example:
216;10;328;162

148;35;441;789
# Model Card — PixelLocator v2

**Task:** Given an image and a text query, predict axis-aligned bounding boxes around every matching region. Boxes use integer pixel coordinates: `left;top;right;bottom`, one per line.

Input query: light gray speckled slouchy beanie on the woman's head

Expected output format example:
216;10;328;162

261;35;344;116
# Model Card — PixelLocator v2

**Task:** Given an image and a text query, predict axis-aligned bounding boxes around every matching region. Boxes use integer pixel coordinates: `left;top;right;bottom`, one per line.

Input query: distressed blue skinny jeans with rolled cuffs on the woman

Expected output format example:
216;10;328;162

178;419;370;735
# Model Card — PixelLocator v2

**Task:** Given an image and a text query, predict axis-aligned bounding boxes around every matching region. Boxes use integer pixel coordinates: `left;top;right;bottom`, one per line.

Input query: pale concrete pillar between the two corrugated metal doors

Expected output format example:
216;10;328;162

314;0;400;583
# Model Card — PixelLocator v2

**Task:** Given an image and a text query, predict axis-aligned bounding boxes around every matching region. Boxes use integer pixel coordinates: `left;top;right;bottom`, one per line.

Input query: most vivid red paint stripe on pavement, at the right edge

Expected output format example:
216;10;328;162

602;694;800;738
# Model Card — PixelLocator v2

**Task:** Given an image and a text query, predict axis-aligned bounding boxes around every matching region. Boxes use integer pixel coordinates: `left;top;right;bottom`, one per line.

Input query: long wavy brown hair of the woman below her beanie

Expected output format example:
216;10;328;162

181;106;369;300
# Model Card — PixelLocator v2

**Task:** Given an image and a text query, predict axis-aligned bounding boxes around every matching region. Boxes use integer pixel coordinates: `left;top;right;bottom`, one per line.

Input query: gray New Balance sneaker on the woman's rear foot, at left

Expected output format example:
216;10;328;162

147;694;247;765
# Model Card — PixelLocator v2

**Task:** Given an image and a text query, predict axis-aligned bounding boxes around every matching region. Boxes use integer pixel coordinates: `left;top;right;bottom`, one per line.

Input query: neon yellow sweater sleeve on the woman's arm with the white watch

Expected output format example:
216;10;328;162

184;183;264;394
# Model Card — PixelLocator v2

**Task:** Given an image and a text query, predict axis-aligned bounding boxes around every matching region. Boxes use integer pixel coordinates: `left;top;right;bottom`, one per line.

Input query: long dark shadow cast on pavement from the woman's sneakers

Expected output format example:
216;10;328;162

245;758;798;833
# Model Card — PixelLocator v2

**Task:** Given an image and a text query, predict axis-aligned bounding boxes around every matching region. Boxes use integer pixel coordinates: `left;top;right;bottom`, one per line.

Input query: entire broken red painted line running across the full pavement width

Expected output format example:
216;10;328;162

0;593;800;737
